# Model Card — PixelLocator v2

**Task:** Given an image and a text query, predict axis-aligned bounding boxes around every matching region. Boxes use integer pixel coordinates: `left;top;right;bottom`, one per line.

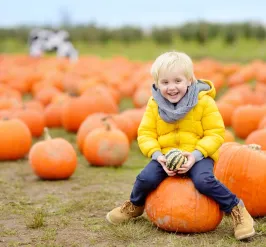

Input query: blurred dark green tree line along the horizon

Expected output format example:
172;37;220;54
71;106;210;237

0;21;266;45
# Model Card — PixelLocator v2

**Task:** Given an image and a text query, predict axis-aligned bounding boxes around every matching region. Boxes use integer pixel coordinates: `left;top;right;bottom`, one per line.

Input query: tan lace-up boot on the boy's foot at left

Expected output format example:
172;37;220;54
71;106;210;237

106;200;144;225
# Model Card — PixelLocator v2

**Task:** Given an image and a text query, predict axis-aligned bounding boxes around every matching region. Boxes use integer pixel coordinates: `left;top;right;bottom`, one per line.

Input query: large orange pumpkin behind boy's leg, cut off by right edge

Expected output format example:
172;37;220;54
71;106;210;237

214;142;266;216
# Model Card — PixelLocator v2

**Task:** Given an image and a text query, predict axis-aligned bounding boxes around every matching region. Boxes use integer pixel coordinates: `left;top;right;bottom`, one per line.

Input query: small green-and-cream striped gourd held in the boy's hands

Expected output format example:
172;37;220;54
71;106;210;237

165;149;187;171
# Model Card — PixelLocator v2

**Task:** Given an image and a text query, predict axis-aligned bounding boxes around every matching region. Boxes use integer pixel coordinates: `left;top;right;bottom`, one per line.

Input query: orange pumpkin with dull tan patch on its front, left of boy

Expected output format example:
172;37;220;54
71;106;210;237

83;123;129;166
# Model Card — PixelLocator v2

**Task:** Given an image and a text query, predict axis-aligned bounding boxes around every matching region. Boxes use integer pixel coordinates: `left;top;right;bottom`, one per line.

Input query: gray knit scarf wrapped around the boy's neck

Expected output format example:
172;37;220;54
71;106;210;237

152;80;211;123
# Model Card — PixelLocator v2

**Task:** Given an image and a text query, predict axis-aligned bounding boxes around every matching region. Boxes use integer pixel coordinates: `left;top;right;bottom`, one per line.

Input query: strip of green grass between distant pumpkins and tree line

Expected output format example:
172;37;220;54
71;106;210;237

0;38;266;62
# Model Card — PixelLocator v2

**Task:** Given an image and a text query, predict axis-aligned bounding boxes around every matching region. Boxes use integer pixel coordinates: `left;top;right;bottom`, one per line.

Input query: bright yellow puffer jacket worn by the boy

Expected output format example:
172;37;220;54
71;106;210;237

138;79;225;161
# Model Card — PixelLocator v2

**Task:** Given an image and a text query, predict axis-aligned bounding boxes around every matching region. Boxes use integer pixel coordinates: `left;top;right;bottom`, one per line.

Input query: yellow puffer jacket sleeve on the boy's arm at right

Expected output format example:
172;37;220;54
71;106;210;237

195;97;225;157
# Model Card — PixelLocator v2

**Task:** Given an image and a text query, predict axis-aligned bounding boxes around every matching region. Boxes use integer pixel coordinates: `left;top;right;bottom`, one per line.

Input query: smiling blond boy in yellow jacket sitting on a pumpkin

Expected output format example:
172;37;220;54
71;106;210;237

106;52;255;240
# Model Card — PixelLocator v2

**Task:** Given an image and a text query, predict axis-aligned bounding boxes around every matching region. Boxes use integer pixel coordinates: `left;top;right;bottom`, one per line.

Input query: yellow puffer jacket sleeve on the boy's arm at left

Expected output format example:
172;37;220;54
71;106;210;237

137;97;161;157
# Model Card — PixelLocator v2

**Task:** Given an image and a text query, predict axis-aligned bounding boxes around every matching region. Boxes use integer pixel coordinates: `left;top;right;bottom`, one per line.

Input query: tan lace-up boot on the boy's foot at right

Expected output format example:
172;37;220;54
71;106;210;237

231;201;255;240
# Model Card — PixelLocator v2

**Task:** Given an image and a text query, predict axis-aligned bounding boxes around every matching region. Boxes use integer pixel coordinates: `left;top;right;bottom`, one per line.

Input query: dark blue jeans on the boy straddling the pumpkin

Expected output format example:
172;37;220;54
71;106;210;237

130;158;239;213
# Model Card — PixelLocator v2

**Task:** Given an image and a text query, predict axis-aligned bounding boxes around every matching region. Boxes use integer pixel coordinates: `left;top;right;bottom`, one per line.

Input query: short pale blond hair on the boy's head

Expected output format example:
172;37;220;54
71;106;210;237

151;51;196;84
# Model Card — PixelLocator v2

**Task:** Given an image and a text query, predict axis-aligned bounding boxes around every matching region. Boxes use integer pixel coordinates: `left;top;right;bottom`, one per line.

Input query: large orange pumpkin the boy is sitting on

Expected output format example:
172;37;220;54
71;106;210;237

145;177;223;233
